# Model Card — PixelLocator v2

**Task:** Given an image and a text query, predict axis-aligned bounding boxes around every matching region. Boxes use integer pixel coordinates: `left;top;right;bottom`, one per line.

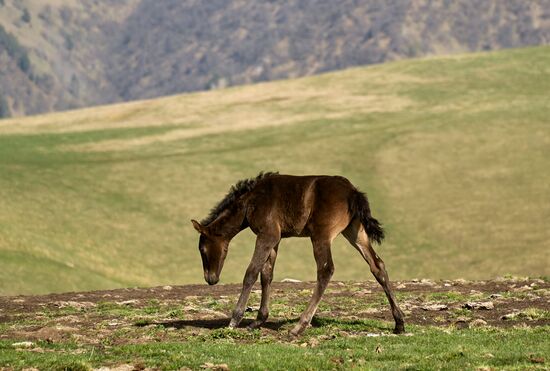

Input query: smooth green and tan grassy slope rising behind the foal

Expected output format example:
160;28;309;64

0;47;550;296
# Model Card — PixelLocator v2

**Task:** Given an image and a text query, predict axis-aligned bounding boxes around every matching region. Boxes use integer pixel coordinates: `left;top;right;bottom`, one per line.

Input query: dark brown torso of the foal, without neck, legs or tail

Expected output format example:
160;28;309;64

247;175;355;237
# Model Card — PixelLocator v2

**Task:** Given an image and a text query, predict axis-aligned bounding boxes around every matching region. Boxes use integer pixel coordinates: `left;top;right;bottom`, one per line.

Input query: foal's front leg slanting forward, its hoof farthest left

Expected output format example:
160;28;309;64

229;234;280;328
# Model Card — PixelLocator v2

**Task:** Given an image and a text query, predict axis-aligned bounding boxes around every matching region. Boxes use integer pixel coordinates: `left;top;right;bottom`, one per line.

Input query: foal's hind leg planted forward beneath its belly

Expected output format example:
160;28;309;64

290;240;334;336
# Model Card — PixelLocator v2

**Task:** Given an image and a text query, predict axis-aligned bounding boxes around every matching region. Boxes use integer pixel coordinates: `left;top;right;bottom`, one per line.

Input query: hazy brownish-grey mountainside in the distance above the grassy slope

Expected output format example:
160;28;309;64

0;0;550;116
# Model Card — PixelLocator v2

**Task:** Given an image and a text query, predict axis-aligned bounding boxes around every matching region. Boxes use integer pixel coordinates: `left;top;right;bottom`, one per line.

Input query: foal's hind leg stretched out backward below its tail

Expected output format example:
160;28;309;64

342;219;405;334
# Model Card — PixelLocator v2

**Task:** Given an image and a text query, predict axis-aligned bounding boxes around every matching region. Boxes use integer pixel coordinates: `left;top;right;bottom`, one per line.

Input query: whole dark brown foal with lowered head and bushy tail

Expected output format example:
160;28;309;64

192;173;405;336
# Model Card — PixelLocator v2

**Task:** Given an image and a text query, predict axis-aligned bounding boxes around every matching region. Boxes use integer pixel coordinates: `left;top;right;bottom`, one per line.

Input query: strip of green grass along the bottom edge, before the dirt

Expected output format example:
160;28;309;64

0;324;550;370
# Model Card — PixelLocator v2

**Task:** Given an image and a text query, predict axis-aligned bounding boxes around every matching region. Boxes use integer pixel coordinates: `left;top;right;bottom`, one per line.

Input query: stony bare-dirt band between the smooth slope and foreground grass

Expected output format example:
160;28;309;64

0;279;550;344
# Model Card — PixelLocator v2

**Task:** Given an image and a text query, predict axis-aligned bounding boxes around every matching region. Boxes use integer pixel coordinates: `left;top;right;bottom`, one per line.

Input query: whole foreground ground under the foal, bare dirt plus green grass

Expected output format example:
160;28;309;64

0;280;550;371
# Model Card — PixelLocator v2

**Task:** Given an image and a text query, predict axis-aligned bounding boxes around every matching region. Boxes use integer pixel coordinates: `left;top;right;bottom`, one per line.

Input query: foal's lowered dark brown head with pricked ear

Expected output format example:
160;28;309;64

191;220;229;285
